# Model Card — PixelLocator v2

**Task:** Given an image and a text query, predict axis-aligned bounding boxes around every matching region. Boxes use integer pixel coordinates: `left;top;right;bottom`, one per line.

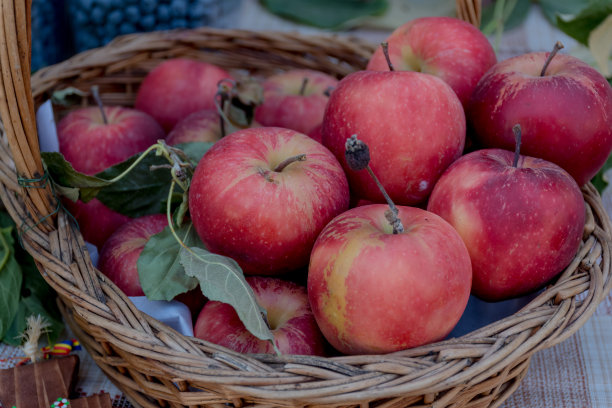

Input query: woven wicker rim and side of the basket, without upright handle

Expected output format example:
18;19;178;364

0;8;612;406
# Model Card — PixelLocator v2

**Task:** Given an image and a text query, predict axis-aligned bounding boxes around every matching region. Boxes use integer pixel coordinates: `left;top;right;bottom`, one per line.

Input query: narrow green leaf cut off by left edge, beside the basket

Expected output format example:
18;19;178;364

0;227;23;340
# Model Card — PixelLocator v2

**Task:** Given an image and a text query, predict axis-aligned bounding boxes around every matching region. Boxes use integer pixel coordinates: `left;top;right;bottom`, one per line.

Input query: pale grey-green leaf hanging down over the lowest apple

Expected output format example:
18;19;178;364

180;248;274;342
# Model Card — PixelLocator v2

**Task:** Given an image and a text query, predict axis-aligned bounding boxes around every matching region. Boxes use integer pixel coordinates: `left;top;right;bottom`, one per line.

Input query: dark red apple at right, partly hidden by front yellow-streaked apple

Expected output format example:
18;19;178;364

427;149;585;301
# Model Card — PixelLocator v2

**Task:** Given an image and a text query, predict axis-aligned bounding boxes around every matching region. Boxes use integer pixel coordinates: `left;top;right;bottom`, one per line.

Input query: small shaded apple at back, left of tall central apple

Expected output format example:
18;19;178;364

255;69;338;134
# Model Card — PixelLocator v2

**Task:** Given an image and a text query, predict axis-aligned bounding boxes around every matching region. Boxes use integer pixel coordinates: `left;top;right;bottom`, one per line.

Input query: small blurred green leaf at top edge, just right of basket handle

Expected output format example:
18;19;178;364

480;0;531;35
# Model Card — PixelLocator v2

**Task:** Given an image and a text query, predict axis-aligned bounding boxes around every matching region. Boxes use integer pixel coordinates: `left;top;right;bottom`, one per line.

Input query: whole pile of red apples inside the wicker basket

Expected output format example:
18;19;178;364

53;17;612;354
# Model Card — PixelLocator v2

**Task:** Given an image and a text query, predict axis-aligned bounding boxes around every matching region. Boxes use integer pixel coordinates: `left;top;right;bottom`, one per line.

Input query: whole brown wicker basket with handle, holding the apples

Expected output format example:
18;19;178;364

0;0;612;408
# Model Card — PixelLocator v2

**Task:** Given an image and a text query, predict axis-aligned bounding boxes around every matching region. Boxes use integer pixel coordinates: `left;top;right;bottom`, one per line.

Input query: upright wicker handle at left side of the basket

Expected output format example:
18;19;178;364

0;0;56;223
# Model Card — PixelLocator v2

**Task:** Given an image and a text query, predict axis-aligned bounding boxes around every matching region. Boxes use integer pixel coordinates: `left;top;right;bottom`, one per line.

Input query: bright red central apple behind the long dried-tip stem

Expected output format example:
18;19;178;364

322;71;465;205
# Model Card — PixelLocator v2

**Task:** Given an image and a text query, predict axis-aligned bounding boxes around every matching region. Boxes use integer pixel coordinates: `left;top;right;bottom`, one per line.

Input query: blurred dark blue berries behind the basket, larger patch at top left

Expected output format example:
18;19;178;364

66;0;240;52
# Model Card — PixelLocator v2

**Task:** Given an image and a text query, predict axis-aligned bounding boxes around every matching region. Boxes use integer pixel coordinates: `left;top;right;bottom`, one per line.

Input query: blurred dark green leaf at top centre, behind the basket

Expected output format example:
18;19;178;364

260;0;388;28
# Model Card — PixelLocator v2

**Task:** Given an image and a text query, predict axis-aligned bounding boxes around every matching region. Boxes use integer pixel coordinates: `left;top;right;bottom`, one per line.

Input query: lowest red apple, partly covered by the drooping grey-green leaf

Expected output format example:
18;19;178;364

194;276;324;356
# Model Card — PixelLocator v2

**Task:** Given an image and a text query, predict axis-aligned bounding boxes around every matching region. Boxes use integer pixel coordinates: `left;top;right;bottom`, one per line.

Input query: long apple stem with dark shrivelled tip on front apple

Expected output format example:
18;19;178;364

344;135;404;234
